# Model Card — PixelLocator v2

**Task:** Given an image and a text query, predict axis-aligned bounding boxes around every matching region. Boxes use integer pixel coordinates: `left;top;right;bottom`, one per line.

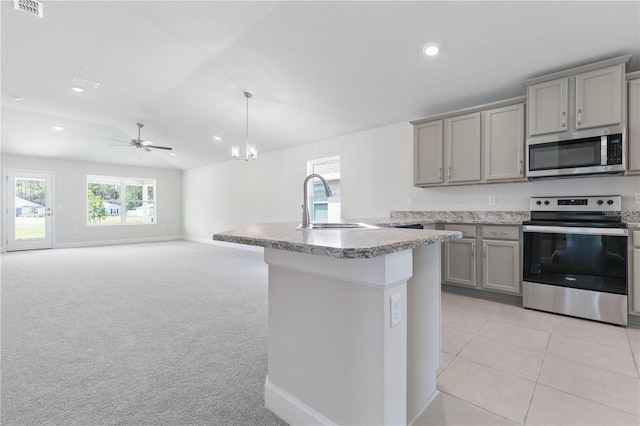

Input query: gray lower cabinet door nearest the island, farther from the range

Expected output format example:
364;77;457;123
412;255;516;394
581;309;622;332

442;238;476;287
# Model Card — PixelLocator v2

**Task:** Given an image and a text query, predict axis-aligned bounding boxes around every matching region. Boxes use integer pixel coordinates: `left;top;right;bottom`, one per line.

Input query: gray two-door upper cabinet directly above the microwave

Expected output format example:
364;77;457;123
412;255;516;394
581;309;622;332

525;61;626;136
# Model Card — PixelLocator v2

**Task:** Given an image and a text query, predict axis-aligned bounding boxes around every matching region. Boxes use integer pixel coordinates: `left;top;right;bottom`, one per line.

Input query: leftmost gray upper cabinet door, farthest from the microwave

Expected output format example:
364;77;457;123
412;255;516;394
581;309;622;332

413;120;442;185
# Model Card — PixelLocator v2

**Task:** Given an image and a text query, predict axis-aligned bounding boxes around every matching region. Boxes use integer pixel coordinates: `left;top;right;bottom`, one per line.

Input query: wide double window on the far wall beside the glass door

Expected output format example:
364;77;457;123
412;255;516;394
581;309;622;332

87;175;156;225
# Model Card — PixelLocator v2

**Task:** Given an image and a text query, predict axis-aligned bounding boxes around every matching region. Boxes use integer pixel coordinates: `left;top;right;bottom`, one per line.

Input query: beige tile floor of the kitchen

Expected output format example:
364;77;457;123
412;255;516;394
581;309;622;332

416;293;640;426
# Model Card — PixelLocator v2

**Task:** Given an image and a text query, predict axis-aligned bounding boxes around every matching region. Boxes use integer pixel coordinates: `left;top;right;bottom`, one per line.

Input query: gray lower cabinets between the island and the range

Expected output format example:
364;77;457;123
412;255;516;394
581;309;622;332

442;224;522;294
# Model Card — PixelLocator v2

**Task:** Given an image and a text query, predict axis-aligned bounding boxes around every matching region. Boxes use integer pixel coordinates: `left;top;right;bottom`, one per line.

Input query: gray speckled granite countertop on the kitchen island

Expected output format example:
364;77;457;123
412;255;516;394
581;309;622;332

213;222;462;259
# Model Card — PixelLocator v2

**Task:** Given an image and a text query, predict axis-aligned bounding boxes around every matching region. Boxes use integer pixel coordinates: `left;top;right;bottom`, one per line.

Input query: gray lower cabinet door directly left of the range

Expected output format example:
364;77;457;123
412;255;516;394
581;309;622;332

482;240;520;294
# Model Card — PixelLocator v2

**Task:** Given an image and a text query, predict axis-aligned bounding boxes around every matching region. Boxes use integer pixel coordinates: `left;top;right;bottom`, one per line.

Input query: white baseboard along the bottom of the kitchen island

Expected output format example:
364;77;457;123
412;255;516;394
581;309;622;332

264;376;336;425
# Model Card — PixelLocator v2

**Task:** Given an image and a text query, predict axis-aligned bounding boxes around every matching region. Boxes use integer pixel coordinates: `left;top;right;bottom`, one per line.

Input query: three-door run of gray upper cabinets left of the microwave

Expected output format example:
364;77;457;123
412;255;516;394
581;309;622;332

411;97;525;186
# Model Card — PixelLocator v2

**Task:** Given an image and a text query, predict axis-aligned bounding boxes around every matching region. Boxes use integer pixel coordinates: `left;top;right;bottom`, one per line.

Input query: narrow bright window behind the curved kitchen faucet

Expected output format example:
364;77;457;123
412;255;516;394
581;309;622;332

307;157;340;222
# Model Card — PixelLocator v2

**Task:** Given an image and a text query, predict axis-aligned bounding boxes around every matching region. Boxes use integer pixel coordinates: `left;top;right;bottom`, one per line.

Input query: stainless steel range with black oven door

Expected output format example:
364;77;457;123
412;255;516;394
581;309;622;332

522;195;628;325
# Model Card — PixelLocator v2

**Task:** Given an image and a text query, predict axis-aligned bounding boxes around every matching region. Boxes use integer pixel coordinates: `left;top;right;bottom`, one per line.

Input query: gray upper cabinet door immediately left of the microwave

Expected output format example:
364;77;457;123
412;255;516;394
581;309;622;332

482;104;524;180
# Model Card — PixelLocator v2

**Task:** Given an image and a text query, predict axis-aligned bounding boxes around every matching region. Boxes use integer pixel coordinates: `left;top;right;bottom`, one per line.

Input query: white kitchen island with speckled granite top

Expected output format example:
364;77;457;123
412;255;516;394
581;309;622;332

213;223;462;425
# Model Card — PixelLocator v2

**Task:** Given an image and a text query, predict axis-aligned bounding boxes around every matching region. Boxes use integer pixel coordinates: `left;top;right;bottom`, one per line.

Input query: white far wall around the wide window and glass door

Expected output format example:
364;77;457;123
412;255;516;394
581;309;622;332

2;155;183;248
